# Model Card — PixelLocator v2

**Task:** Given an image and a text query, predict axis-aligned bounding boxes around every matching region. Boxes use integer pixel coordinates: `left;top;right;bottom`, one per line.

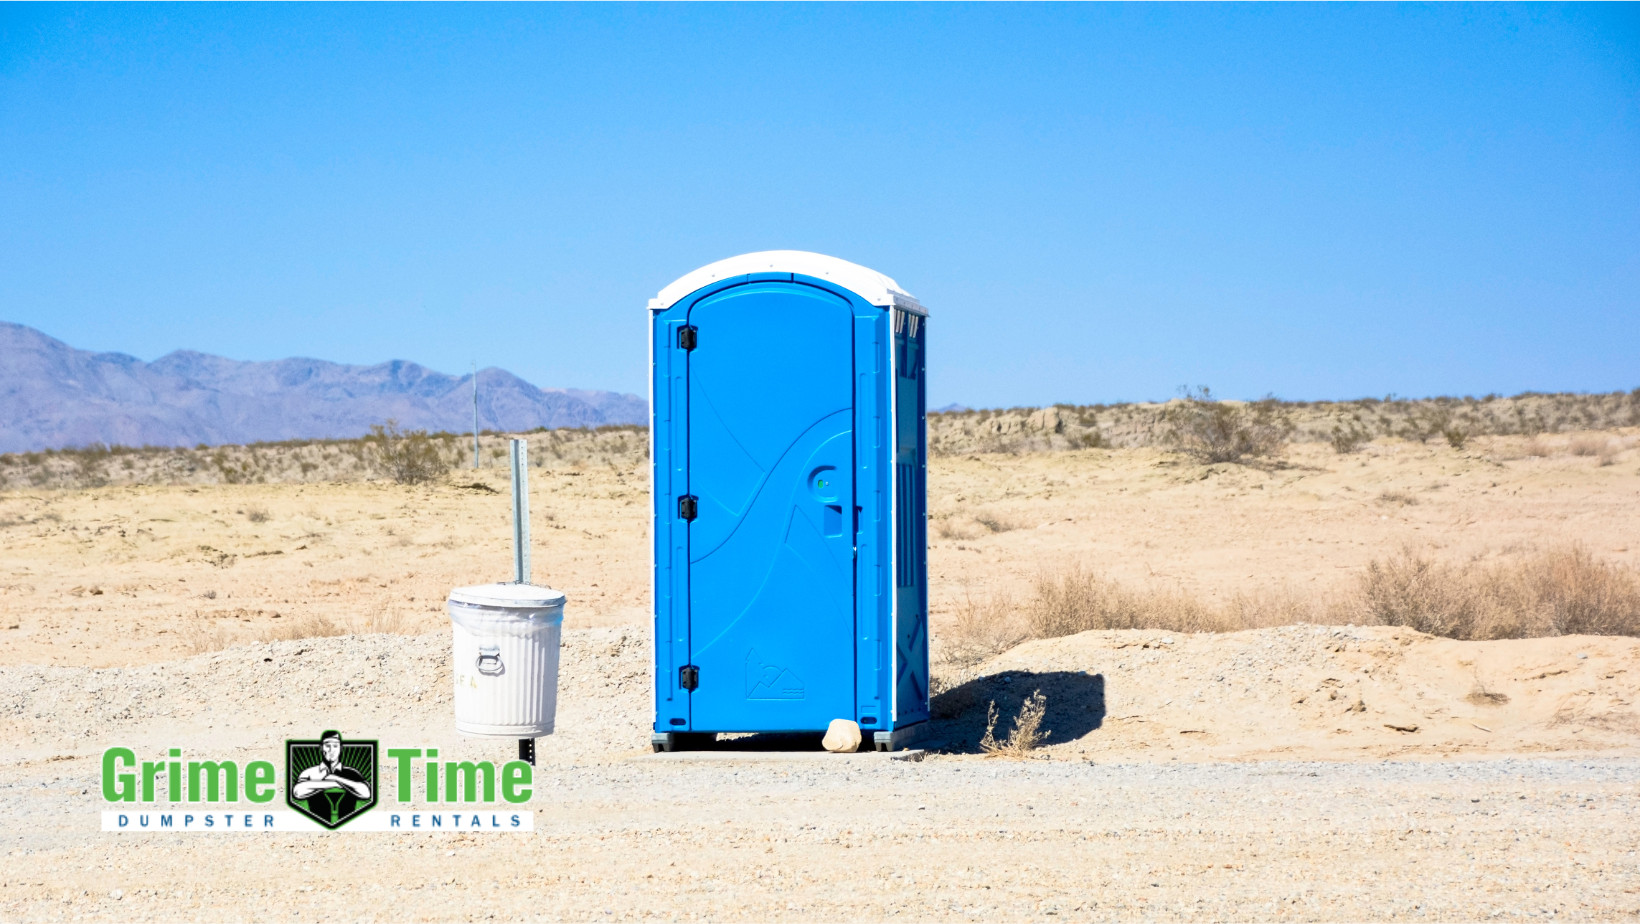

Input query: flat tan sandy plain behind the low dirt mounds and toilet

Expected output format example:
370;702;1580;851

0;437;1640;666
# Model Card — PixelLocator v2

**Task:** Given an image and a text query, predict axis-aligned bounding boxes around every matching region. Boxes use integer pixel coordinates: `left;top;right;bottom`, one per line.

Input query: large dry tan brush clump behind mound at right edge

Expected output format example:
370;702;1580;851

1358;547;1640;638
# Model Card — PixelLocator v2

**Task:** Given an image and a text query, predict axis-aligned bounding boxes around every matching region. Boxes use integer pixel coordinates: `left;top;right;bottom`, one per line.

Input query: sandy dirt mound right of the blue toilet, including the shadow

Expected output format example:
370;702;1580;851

933;625;1640;760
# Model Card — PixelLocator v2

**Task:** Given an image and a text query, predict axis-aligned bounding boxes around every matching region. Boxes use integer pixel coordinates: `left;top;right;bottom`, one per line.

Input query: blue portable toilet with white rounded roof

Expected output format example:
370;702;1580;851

649;251;928;750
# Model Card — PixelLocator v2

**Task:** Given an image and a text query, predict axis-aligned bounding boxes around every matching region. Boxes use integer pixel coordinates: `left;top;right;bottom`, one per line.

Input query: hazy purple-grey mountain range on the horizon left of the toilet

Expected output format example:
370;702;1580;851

0;322;649;453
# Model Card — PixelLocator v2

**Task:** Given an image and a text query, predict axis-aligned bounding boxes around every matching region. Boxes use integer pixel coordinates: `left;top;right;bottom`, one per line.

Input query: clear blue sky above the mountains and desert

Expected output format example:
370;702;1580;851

0;3;1640;407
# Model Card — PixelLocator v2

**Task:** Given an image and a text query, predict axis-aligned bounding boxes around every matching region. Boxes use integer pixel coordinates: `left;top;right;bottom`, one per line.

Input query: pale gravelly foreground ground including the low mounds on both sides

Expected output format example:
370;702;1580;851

0;627;1640;921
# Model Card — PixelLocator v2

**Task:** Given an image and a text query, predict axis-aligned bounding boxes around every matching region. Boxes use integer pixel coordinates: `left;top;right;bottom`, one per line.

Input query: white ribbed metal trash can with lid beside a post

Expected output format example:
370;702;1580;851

448;584;564;739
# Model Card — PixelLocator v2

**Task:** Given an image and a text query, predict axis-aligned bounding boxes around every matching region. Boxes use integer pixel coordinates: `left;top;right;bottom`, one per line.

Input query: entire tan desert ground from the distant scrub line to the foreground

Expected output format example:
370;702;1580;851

0;428;1640;921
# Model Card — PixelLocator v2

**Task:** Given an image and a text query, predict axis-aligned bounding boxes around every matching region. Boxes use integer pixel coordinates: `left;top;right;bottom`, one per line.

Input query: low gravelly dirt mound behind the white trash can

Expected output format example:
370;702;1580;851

0;629;651;763
